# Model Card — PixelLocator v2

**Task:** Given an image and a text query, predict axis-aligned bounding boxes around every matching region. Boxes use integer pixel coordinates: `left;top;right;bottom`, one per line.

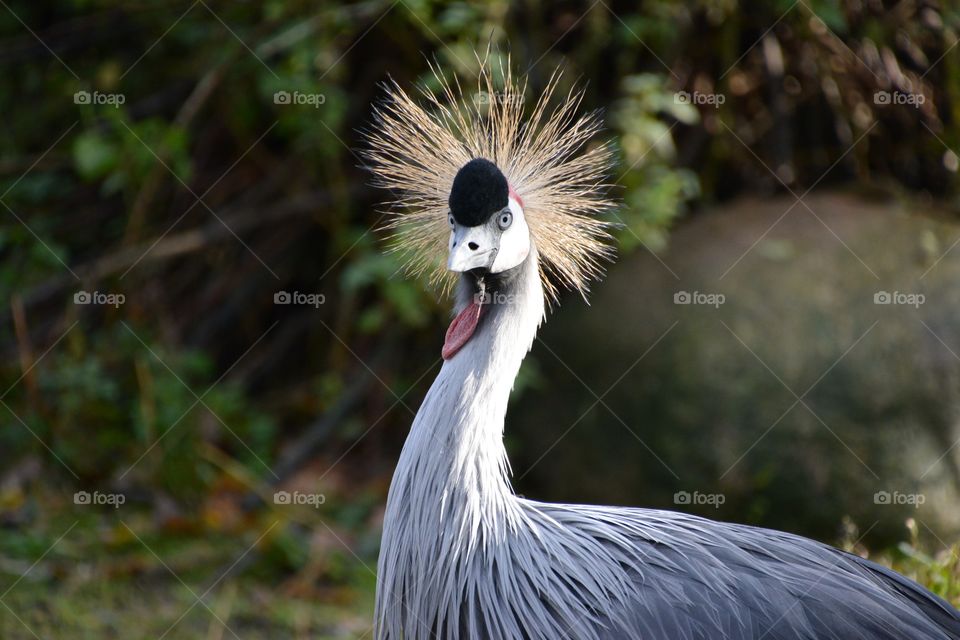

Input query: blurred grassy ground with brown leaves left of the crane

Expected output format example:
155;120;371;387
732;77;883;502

0;484;376;640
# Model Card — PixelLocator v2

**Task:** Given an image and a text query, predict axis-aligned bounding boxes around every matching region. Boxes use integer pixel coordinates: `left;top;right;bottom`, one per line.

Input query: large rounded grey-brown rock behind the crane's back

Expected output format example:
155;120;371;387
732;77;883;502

507;193;960;540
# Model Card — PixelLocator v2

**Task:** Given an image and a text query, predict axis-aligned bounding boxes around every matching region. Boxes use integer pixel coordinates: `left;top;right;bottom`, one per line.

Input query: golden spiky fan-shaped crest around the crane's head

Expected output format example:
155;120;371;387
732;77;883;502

365;56;615;302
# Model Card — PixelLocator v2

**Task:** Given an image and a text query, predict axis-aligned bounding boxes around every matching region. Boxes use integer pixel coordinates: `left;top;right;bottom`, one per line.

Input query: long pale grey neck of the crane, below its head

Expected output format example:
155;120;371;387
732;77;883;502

387;248;544;537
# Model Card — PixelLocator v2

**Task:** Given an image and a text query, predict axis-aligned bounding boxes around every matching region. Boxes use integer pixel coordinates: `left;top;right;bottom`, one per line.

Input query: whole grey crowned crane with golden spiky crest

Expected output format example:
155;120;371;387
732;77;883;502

366;61;960;640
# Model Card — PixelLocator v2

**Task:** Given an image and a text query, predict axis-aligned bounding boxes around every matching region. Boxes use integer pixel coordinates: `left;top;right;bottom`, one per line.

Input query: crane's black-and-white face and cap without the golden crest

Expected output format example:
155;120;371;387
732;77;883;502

447;158;530;273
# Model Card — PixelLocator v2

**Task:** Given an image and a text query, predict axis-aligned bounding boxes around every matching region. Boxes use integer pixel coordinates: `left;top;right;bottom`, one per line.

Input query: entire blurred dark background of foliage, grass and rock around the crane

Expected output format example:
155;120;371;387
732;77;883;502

0;0;960;638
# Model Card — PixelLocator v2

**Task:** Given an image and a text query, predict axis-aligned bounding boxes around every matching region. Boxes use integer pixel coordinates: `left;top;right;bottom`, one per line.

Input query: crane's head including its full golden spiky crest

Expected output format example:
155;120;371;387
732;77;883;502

363;56;617;302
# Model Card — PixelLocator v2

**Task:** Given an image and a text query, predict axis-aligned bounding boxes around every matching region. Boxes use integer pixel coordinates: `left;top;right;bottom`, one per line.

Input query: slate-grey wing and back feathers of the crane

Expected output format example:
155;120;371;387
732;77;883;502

537;504;960;640
